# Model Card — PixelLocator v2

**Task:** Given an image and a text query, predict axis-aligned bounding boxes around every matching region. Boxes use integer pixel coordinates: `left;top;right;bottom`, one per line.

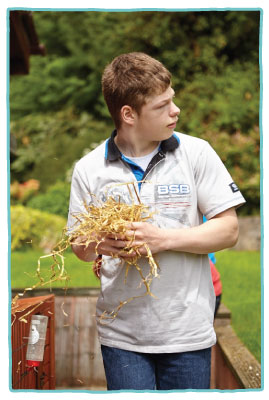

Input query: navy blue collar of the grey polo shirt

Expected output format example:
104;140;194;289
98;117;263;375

105;129;180;161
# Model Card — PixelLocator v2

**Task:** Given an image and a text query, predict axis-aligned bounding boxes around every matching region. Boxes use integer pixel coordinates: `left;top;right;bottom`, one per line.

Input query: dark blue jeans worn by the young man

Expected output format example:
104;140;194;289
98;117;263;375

101;345;211;390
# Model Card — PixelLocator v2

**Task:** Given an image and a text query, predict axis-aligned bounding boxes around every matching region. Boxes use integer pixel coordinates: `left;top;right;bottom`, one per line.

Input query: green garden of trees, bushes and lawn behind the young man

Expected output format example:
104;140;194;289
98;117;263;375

10;11;261;360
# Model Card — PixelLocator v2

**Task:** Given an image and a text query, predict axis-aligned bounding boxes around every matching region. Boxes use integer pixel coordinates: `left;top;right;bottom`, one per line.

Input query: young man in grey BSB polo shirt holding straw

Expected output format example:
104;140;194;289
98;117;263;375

68;53;245;390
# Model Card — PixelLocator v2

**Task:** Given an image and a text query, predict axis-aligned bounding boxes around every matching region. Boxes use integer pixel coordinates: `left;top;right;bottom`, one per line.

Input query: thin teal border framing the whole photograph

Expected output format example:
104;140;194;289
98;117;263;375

6;7;264;394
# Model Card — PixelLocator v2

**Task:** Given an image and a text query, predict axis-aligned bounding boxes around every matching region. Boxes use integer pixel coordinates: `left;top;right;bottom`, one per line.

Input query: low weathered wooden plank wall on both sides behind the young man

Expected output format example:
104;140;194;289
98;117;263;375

11;288;261;390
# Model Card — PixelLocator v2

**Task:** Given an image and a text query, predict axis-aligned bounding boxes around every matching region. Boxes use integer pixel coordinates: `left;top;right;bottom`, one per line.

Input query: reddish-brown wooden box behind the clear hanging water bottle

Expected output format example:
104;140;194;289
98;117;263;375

11;295;55;390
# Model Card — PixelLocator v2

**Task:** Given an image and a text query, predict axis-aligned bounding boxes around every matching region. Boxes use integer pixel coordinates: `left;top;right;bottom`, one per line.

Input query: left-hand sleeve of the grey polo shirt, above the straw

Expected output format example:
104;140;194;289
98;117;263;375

67;162;92;233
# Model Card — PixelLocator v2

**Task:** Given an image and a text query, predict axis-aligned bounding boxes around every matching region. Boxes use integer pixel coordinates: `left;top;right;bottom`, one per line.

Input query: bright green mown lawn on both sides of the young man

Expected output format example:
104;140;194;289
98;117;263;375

11;250;261;362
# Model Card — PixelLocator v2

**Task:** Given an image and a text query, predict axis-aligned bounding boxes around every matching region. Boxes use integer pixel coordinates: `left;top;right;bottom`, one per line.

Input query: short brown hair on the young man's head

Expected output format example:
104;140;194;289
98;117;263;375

102;52;171;128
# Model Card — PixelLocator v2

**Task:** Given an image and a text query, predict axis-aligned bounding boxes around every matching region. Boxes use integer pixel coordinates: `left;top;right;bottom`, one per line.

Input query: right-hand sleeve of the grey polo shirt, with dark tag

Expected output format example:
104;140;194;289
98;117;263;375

195;142;245;219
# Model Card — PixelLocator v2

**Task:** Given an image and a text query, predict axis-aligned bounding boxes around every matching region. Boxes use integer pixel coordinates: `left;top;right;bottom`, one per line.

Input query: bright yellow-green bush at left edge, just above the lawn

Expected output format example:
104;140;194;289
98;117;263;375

10;205;66;252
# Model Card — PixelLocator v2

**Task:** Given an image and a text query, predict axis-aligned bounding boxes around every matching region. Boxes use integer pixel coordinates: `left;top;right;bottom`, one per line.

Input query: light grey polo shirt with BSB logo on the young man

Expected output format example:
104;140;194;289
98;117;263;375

68;132;245;353
